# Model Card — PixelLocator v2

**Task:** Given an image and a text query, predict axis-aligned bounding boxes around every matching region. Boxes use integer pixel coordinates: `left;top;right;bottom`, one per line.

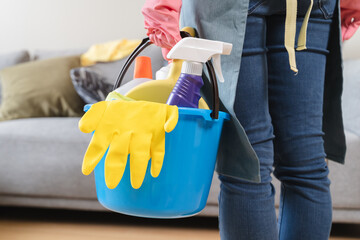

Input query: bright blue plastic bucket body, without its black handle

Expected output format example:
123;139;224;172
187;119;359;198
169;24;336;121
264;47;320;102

94;108;229;218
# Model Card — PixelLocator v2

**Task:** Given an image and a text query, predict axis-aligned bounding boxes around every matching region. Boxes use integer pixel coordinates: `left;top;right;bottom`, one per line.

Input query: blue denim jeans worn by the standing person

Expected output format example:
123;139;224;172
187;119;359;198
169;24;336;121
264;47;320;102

219;0;335;240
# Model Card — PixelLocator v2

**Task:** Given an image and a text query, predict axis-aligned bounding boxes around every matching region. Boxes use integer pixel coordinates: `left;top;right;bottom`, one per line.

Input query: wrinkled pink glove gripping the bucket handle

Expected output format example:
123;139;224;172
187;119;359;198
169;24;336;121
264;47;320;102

141;0;182;60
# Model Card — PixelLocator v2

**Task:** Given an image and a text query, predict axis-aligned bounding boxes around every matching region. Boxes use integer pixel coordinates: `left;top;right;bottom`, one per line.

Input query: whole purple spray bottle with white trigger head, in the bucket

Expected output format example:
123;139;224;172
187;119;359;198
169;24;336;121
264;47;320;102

166;37;232;108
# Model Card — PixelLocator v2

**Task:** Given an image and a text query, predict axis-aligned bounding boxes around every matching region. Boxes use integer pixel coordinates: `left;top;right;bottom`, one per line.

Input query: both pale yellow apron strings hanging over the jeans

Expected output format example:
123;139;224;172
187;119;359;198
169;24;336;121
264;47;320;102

284;0;314;74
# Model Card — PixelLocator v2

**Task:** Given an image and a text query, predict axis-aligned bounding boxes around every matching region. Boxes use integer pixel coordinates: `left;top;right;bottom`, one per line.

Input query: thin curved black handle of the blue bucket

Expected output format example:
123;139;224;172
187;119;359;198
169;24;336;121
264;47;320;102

113;31;220;119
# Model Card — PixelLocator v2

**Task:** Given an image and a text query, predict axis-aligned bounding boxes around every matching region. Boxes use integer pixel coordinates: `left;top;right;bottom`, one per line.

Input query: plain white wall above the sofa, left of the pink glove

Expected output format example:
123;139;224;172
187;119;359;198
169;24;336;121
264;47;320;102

0;0;146;52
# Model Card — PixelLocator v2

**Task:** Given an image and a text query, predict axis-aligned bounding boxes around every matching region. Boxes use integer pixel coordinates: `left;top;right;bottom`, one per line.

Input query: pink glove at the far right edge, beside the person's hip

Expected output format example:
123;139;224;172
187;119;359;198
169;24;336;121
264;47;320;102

340;0;360;41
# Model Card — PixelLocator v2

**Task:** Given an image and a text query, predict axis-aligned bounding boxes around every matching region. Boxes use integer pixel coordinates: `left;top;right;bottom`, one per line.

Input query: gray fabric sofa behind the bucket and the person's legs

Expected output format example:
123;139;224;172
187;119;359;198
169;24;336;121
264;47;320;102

0;49;360;223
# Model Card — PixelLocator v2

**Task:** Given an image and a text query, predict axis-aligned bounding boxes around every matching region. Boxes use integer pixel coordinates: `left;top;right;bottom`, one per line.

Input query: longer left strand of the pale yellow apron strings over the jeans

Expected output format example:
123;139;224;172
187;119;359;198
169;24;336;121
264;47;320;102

284;0;298;73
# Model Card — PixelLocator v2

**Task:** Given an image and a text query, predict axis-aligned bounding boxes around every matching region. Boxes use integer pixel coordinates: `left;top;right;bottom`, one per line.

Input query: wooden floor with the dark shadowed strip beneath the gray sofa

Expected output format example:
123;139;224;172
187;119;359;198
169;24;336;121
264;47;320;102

0;207;360;240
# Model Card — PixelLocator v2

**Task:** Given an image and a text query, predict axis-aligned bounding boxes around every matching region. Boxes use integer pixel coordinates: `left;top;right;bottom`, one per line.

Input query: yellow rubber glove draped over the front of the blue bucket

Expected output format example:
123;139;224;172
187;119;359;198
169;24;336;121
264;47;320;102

79;100;179;189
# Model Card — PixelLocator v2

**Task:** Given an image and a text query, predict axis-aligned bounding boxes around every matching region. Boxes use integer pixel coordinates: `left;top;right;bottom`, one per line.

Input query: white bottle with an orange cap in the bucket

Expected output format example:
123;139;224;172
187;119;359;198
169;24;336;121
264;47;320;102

115;56;152;95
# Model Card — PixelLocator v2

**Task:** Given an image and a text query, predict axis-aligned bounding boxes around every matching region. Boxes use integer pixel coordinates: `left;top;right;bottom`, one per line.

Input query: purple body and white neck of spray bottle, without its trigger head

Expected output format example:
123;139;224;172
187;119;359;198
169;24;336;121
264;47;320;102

166;61;204;108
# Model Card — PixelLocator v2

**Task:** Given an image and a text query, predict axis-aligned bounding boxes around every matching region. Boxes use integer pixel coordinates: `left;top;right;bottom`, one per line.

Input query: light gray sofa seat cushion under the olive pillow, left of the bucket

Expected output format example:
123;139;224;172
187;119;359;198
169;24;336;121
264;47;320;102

0;118;96;199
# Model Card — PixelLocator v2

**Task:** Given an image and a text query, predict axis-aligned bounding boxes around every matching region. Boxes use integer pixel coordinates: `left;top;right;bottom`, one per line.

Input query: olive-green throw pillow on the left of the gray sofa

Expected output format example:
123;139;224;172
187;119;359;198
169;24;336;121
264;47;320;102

0;56;84;121
